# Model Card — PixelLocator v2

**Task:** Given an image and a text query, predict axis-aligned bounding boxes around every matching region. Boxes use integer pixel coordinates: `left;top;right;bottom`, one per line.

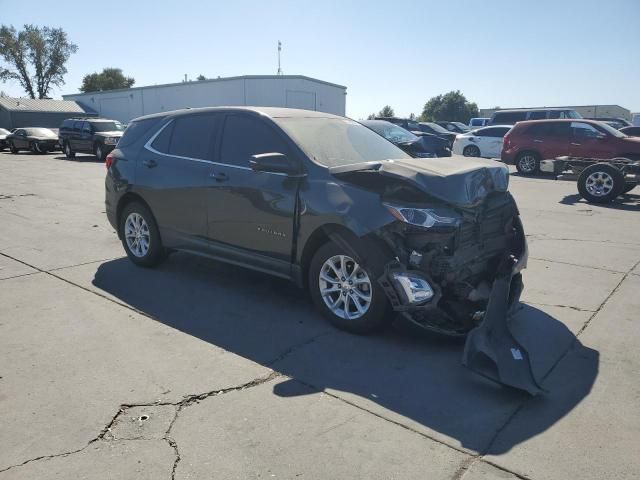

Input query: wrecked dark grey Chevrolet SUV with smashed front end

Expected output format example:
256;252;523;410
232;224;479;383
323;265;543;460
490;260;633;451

105;107;529;394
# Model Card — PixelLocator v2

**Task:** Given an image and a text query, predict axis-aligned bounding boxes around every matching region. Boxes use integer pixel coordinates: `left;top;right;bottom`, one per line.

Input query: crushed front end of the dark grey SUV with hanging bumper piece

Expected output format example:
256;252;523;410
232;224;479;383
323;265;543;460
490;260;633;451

332;159;541;395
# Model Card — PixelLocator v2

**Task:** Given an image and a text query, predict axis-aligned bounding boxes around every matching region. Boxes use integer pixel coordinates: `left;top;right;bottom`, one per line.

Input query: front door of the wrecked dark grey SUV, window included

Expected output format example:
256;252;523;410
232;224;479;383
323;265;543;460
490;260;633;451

207;113;300;276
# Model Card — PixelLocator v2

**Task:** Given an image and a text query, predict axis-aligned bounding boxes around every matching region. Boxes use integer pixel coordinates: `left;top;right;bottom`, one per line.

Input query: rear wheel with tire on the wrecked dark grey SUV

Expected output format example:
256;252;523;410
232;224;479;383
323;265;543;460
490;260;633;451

119;202;166;268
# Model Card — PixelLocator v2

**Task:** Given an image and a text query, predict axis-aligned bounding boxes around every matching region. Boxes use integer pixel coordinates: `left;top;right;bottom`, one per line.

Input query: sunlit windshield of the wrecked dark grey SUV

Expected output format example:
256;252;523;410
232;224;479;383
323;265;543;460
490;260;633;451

274;117;411;167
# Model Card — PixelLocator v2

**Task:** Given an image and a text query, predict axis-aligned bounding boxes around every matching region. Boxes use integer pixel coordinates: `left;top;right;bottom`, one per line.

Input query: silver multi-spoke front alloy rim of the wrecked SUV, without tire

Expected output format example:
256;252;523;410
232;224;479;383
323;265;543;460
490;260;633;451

319;255;372;320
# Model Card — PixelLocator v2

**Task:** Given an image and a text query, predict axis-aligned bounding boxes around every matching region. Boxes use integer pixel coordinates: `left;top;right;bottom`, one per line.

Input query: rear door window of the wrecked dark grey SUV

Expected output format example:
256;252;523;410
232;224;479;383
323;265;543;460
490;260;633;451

165;114;221;160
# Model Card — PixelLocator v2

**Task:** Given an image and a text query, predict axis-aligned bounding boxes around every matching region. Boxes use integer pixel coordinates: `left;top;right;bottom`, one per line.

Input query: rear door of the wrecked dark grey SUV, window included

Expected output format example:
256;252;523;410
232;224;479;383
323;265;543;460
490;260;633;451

136;113;223;251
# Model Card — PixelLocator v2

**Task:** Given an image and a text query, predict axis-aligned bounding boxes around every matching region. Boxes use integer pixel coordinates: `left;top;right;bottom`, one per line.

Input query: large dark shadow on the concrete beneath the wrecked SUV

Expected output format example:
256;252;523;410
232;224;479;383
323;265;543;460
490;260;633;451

93;254;598;453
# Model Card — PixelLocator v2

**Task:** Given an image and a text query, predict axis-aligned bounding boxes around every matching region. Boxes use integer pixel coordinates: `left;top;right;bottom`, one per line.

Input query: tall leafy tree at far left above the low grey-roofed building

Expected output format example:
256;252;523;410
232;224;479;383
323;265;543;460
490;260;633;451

0;25;78;98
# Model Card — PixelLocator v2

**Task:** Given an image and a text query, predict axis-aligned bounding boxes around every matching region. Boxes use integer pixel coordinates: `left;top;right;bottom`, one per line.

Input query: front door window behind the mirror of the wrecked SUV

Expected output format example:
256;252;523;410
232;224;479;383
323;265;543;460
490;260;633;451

220;115;289;167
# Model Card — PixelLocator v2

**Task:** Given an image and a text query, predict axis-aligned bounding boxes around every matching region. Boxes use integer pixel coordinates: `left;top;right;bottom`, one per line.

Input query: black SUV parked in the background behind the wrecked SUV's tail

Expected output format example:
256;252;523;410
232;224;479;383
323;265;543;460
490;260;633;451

58;117;124;161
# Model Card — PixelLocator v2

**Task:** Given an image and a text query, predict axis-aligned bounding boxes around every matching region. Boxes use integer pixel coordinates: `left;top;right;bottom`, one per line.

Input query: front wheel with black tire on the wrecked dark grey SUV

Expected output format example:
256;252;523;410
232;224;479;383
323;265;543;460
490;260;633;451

308;242;393;334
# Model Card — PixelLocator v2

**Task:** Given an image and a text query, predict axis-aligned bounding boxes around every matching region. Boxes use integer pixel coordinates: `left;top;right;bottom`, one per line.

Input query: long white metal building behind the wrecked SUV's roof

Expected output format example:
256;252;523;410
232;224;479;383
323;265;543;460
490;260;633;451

62;75;347;123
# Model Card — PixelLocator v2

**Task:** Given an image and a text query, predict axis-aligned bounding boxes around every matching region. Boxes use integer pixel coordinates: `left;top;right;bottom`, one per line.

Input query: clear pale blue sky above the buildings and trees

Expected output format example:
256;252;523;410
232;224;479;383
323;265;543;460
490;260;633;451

0;0;640;118
